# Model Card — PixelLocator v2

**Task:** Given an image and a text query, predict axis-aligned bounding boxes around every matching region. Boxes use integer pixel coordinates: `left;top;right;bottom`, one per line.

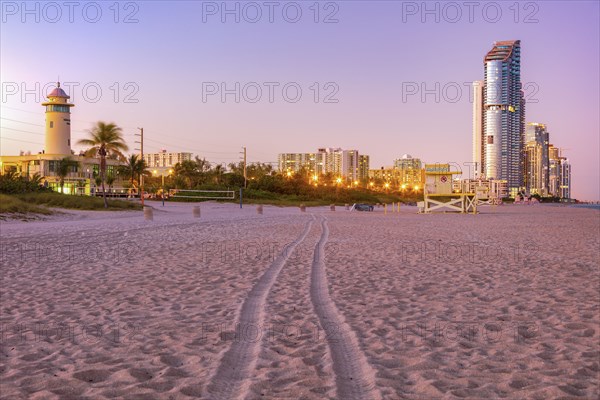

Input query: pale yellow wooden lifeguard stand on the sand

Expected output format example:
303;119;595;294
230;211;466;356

418;164;477;214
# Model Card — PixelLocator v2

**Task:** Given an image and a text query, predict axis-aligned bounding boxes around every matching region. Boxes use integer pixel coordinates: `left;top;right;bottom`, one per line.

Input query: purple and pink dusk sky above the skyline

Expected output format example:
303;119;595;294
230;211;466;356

0;1;600;200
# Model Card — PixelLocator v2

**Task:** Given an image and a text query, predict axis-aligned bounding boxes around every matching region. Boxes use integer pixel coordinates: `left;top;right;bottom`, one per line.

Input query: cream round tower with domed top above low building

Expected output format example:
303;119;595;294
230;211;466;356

42;82;75;156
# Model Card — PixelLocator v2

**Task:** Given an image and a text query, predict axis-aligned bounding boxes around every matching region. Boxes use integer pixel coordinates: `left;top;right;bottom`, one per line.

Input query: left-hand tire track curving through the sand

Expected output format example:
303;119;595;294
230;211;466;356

203;216;315;399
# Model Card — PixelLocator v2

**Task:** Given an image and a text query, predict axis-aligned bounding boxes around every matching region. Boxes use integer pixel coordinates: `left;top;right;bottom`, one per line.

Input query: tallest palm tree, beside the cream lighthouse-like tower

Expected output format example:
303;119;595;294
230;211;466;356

77;121;128;208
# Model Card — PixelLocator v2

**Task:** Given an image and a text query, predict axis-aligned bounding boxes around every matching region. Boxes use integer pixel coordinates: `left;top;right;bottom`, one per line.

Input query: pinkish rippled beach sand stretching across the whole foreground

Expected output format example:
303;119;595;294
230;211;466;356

0;203;600;399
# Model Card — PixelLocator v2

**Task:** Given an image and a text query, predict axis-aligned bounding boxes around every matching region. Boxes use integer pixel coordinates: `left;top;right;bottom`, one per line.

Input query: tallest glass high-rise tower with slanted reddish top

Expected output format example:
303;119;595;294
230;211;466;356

482;40;525;195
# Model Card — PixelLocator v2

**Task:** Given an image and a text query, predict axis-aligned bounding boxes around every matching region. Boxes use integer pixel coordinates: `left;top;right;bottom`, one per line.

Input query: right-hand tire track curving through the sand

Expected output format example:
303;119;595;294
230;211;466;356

310;217;381;400
